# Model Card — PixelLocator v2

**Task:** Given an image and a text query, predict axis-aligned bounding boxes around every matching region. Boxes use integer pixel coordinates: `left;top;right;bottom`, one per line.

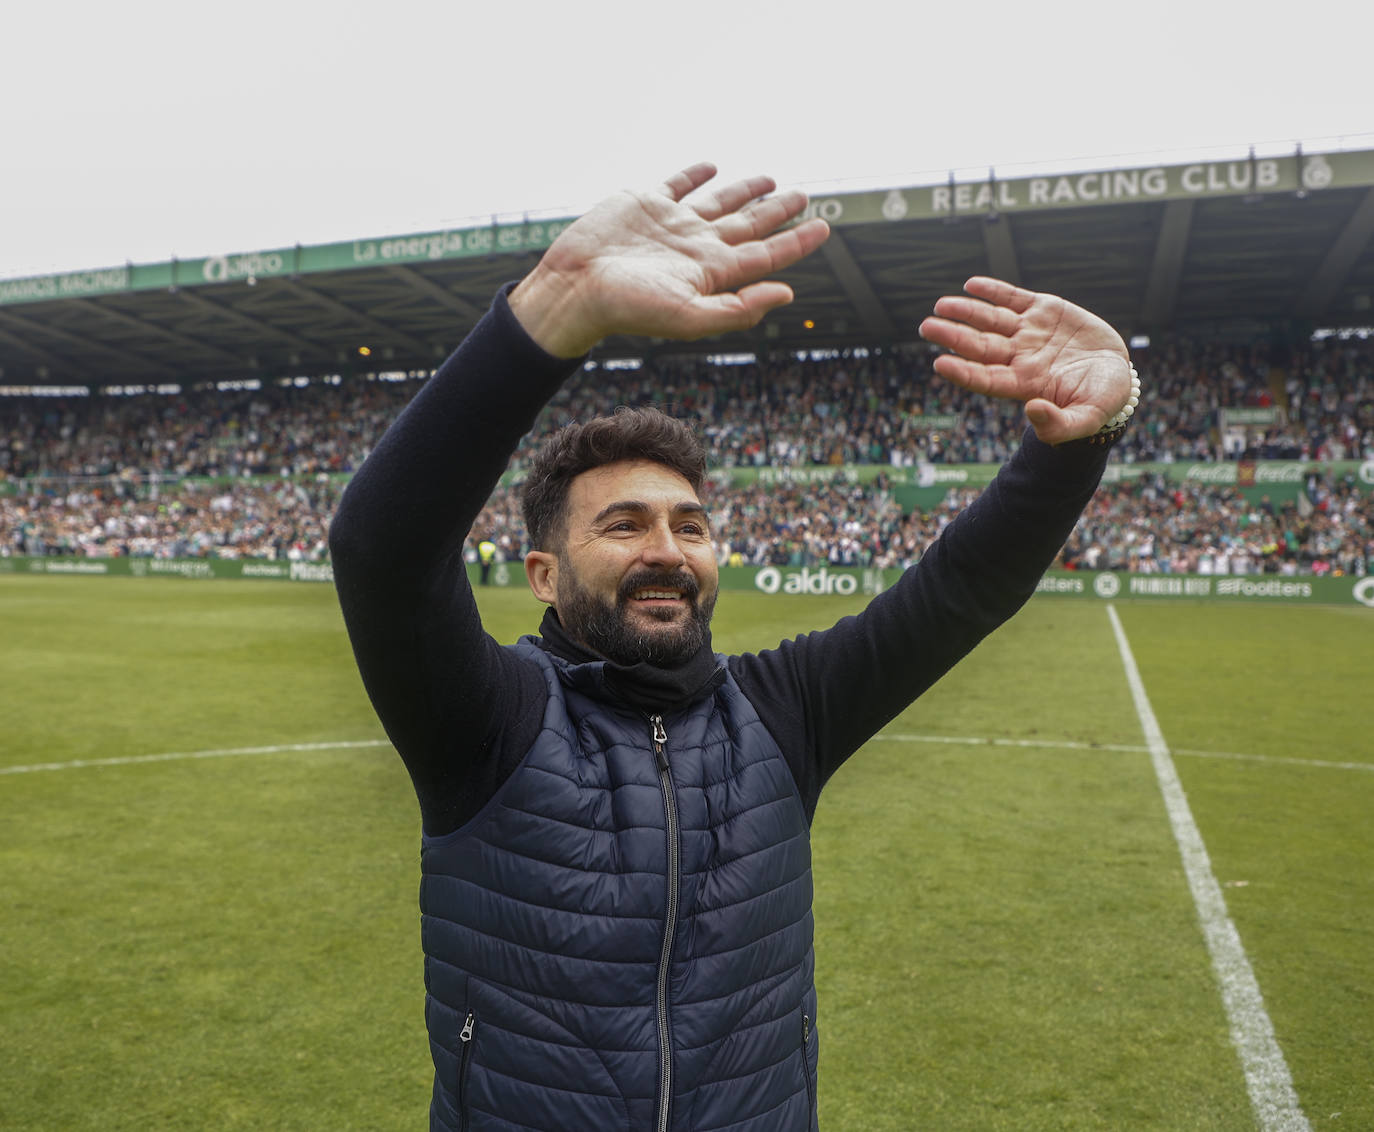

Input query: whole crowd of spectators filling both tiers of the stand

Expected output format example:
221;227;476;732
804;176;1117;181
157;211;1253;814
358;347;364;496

0;331;1374;574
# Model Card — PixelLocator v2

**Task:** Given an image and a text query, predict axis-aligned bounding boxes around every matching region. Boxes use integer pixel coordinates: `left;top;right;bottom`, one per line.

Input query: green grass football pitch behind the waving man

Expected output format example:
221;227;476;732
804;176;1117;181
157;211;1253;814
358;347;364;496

0;576;1374;1132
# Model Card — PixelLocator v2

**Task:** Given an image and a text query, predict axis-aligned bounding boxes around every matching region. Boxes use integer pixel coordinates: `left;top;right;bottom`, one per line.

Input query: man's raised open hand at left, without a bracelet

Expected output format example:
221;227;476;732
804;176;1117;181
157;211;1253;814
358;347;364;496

510;162;830;357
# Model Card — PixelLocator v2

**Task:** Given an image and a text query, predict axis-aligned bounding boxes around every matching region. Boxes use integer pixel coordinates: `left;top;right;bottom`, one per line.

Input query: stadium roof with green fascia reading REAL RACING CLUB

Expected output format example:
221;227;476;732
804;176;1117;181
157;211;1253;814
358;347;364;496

0;151;1374;386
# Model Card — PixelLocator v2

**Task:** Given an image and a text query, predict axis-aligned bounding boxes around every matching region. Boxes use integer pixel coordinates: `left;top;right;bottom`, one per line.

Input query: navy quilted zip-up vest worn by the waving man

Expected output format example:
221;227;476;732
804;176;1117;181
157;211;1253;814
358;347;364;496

420;637;818;1132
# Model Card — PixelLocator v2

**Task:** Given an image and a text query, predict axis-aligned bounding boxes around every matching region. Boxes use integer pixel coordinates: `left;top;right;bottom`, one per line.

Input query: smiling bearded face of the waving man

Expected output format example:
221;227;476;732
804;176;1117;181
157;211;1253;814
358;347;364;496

525;460;719;668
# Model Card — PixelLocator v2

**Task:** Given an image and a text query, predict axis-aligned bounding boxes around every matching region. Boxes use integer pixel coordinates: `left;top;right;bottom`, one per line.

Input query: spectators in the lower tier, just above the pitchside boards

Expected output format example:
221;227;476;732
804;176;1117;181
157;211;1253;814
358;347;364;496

0;461;1374;576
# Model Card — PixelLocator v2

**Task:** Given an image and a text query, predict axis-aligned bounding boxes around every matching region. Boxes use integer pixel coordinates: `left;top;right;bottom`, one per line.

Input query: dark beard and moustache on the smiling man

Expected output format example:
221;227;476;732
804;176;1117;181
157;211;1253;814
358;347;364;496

558;562;716;668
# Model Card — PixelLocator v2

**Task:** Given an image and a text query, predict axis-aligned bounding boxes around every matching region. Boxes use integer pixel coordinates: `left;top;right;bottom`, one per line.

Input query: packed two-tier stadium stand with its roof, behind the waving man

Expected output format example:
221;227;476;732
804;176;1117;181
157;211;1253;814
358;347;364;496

0;151;1374;576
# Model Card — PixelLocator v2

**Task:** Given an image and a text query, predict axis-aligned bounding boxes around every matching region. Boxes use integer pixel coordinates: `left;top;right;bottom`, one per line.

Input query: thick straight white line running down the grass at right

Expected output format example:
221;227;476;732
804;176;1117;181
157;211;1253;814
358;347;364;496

1107;604;1312;1132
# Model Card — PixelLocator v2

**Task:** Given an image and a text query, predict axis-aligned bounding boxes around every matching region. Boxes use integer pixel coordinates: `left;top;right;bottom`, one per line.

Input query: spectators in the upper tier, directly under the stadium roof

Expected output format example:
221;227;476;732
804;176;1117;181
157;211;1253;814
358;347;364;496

0;338;1374;478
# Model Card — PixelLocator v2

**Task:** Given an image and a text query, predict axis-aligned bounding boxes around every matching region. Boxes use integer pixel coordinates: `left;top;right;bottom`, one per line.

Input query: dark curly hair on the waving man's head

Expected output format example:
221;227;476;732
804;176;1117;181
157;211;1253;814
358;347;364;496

521;407;706;551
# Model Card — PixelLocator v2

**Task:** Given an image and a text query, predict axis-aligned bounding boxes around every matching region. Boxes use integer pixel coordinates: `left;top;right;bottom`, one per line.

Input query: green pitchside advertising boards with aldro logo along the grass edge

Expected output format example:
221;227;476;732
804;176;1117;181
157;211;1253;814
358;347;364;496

0;558;1374;609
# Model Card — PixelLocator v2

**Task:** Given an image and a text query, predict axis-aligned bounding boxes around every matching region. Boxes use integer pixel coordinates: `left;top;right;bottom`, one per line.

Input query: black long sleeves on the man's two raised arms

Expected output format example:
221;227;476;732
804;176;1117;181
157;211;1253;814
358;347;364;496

330;291;1106;835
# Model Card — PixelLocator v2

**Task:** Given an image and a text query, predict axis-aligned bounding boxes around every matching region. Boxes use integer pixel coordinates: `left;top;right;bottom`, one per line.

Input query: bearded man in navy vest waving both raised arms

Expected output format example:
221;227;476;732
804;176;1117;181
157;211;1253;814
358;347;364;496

330;165;1132;1132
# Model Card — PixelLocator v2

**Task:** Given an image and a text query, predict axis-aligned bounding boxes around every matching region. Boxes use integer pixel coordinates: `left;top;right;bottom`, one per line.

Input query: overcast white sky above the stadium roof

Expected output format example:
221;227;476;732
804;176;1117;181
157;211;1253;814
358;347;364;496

0;0;1374;278
